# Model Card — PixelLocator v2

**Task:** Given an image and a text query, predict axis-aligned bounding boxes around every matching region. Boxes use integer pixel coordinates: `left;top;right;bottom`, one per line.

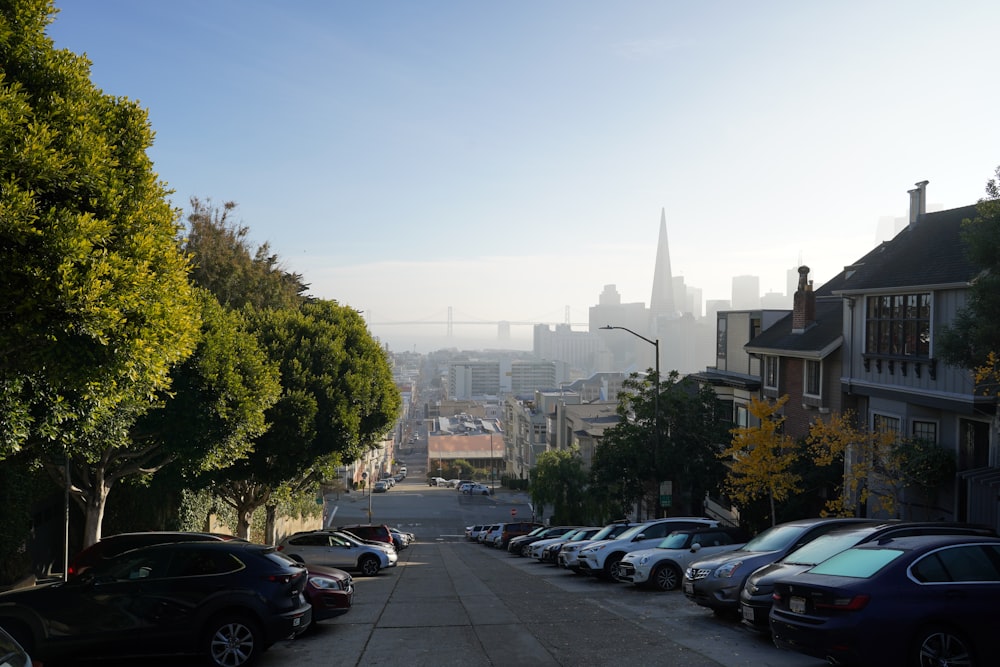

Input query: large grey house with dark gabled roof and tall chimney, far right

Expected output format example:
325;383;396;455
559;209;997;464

812;181;1000;530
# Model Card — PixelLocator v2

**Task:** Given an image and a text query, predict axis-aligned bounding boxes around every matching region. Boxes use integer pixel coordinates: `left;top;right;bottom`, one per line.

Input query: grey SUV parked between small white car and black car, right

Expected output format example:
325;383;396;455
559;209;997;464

682;518;876;616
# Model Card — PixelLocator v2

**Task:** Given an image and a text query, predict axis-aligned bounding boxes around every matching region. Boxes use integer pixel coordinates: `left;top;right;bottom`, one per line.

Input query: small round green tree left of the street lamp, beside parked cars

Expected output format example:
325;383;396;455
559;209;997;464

531;448;589;524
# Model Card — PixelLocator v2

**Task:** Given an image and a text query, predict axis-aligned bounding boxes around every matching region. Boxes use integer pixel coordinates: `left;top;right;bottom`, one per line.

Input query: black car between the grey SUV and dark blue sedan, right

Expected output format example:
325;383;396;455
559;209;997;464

740;521;996;632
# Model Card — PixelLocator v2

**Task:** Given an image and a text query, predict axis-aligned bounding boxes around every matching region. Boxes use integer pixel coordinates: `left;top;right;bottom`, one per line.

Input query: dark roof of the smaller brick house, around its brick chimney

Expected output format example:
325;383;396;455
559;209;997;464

743;296;844;359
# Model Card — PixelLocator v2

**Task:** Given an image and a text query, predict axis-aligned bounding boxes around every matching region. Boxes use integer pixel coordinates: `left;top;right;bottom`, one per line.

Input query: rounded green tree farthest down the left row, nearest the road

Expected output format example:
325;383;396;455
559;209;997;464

206;300;401;539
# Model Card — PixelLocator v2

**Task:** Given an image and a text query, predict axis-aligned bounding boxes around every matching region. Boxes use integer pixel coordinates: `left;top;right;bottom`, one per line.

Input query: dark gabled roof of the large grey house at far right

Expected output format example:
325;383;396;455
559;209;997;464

816;204;979;296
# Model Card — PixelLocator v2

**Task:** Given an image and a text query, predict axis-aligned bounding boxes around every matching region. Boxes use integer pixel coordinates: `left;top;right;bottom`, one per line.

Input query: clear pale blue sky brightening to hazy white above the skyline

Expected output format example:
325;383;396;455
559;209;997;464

49;0;1000;351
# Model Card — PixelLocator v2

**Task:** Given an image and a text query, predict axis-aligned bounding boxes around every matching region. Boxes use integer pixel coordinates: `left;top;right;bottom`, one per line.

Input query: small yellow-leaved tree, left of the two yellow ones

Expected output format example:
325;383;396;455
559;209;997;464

720;394;800;526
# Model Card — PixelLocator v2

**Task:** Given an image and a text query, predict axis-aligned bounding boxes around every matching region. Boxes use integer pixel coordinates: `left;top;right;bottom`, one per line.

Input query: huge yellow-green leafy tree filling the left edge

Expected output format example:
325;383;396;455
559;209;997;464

0;0;205;536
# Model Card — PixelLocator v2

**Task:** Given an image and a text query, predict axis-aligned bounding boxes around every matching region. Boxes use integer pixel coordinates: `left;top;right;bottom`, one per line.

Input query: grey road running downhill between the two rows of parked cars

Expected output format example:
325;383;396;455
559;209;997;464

250;478;825;667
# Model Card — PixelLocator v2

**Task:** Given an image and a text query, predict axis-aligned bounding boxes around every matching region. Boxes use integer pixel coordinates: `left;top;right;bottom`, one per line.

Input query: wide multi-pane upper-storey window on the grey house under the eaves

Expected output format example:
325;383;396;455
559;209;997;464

865;293;931;359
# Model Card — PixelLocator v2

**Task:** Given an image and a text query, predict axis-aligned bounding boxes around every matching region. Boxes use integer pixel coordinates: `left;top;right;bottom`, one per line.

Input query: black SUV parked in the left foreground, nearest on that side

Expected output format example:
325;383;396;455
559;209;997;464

0;540;312;667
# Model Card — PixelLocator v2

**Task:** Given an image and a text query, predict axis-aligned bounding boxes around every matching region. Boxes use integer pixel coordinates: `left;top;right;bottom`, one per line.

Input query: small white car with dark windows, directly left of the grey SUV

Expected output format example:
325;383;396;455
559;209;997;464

618;526;747;591
